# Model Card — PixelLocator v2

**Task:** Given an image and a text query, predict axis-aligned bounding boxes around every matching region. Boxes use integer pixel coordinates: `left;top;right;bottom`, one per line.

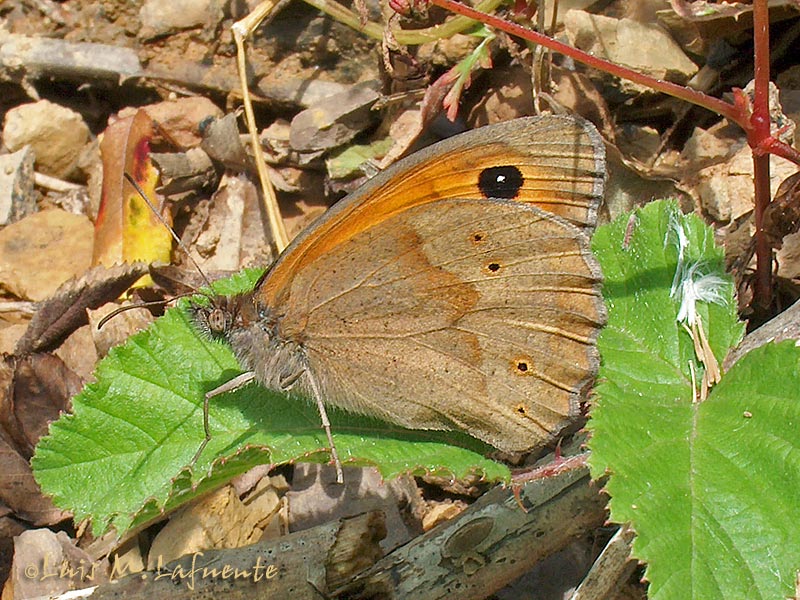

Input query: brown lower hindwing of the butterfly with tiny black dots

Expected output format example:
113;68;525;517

281;199;605;451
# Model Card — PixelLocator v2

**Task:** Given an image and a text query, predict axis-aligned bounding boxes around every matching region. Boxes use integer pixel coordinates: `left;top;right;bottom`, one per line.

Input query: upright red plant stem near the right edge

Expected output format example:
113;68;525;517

748;0;772;308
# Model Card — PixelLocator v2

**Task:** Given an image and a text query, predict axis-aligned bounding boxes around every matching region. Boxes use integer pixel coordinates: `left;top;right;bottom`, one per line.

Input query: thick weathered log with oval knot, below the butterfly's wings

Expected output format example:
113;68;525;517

334;465;607;600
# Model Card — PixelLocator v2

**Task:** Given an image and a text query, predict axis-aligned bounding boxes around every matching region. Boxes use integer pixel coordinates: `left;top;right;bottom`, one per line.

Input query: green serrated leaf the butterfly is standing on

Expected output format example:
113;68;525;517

32;271;509;535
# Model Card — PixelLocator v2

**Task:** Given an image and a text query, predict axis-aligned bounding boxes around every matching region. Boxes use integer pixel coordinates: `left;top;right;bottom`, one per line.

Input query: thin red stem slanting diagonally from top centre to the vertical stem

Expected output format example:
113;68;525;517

430;0;749;125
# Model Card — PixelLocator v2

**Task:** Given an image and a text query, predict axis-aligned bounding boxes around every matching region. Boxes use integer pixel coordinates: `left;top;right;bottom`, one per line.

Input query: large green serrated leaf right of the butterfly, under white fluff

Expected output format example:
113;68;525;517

589;202;800;600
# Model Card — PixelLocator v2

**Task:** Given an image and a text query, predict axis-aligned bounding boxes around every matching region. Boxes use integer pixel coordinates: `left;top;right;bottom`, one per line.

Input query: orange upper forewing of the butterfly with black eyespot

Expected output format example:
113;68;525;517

259;116;605;306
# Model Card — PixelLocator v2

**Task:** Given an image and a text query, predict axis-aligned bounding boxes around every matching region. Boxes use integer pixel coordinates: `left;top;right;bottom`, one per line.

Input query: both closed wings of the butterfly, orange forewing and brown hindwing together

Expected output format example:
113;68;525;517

255;117;605;451
